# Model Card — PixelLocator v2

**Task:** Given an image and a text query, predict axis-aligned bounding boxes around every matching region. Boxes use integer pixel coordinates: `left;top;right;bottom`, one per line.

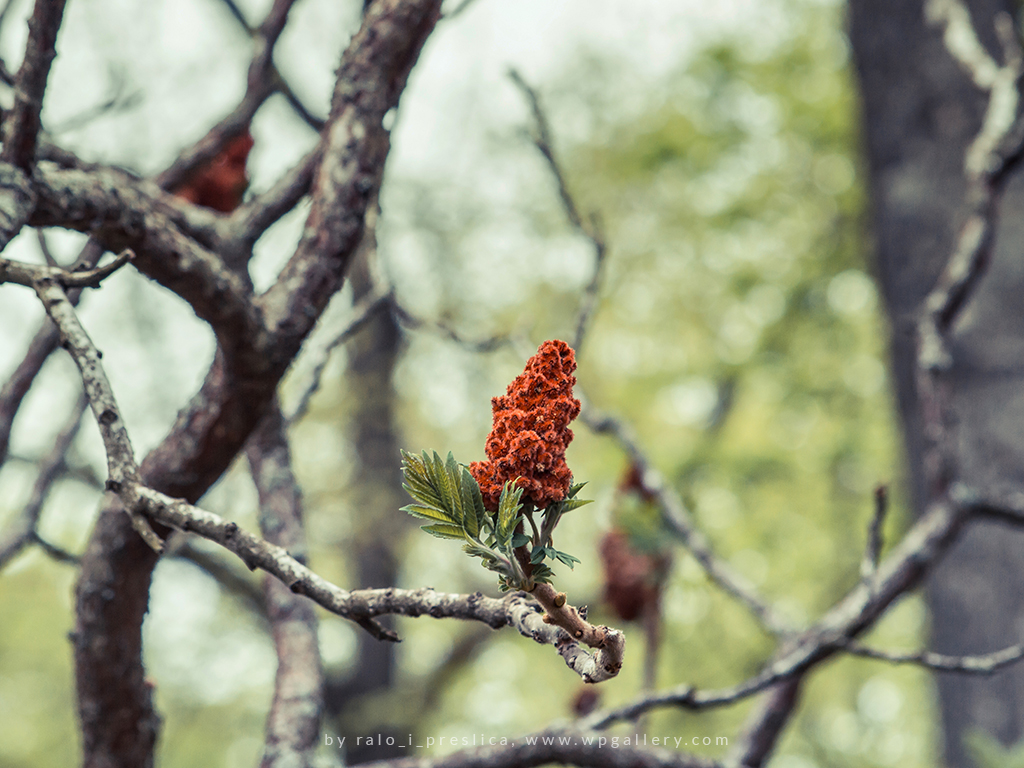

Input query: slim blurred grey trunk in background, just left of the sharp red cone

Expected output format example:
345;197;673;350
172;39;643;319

327;210;409;764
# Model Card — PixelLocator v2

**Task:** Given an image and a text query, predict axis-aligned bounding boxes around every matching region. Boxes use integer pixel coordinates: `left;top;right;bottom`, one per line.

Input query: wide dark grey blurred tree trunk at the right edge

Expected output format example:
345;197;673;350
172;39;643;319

849;0;1024;767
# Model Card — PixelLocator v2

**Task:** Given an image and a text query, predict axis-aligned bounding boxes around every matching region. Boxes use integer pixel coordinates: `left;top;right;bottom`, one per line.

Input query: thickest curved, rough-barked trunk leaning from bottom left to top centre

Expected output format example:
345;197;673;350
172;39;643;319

61;0;439;768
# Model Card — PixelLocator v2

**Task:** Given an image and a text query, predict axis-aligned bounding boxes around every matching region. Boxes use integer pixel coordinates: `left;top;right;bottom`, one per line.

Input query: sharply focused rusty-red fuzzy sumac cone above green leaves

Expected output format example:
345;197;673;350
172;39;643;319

469;341;580;511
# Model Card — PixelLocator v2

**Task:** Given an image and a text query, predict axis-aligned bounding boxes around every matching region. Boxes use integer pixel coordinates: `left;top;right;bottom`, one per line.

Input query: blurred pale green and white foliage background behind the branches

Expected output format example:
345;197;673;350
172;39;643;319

0;0;937;768
